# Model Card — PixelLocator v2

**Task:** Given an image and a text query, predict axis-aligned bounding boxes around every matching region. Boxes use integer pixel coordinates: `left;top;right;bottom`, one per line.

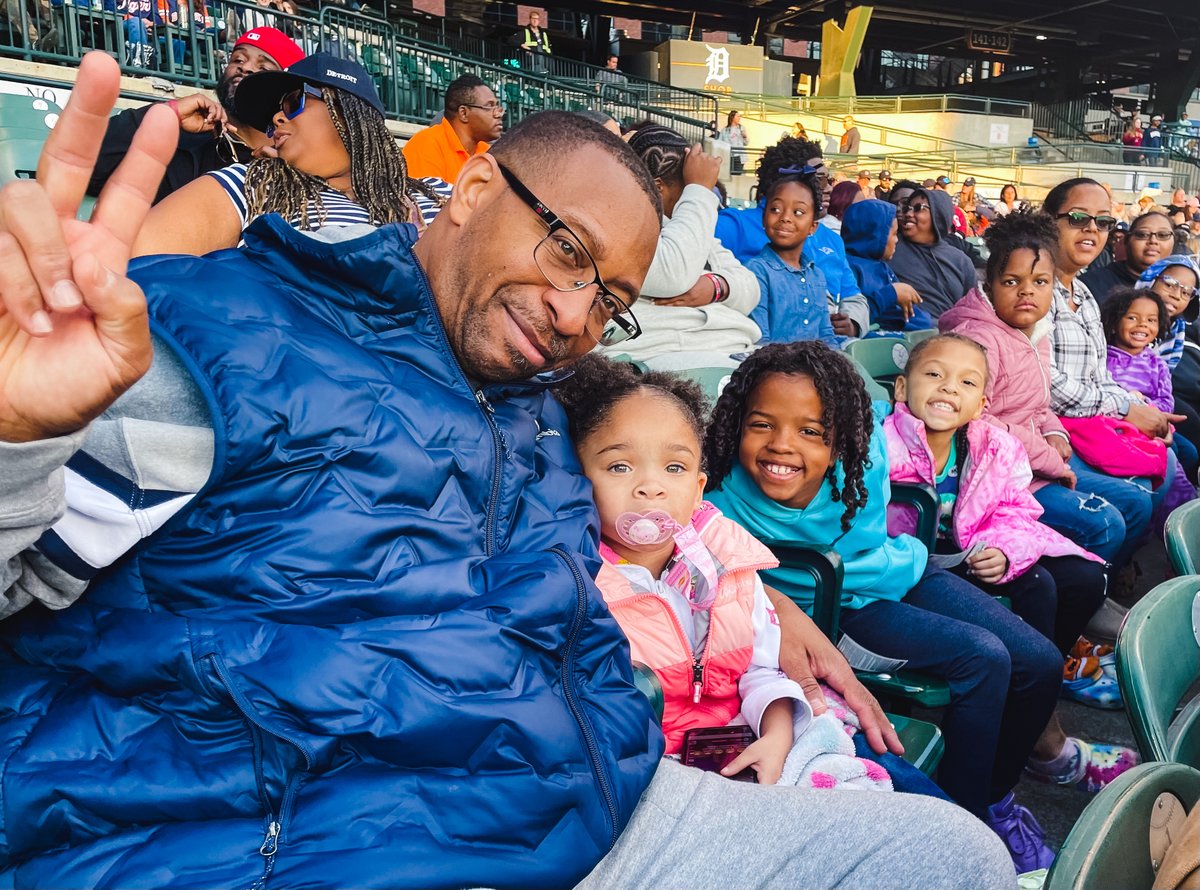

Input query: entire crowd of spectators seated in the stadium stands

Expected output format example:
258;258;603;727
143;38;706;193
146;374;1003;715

0;33;1200;888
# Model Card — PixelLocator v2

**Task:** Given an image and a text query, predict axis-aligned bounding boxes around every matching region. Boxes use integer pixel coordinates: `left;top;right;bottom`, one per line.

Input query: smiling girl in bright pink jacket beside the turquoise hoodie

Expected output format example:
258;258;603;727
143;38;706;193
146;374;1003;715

883;333;1138;790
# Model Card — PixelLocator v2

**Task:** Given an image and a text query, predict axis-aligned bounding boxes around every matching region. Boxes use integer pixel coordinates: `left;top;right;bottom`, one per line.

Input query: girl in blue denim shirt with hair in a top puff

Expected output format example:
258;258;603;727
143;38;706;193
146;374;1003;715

746;174;841;347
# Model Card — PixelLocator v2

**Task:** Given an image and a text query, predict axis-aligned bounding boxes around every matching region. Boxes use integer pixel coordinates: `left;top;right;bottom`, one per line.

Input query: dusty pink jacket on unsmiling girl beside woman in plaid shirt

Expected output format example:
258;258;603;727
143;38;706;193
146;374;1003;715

937;288;1070;491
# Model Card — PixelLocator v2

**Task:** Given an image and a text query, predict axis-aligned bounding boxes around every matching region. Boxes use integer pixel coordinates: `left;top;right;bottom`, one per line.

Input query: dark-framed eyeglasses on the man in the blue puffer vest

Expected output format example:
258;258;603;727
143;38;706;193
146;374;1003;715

499;164;642;347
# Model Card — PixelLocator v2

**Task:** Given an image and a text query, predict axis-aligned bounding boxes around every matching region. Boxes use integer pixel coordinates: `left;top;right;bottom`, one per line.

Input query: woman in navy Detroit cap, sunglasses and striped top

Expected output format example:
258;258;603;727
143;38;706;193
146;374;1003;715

134;53;449;255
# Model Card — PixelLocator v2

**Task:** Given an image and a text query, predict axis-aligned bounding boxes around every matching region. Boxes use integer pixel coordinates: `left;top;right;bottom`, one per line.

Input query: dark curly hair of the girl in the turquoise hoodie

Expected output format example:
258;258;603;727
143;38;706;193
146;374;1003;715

704;339;875;531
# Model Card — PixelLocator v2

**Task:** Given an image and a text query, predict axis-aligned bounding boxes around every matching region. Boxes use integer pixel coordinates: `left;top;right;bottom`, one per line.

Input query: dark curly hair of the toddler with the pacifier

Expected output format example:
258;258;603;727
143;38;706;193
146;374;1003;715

554;353;708;460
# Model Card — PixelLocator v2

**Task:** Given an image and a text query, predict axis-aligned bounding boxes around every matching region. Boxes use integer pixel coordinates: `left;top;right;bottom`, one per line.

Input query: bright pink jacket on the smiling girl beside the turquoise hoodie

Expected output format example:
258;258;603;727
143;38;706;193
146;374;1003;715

883;403;1103;584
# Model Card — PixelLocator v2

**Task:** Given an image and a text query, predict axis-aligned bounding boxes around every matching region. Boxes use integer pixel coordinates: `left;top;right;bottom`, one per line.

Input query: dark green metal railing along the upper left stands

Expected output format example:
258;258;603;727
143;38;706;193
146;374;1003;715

0;0;715;140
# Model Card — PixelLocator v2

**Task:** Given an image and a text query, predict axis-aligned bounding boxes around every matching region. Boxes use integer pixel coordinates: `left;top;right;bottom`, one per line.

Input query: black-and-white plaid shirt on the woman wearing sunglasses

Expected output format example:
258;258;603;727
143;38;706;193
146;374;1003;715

1048;277;1129;417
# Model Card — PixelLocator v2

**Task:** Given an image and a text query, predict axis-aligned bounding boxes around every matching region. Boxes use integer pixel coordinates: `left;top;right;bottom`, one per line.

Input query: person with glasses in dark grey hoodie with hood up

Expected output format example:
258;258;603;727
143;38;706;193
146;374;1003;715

890;185;976;319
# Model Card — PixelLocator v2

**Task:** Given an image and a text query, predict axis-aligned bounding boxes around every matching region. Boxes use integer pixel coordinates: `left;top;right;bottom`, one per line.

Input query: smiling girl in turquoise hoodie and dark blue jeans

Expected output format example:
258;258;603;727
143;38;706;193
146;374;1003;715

704;342;1062;872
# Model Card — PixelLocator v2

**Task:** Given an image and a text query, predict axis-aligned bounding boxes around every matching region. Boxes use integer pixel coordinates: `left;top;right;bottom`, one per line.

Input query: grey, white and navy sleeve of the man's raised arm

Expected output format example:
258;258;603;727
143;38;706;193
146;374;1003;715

0;341;214;618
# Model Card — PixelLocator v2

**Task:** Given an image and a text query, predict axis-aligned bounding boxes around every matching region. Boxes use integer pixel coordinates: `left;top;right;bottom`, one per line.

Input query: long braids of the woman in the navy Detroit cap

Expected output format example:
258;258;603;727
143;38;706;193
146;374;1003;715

246;86;444;229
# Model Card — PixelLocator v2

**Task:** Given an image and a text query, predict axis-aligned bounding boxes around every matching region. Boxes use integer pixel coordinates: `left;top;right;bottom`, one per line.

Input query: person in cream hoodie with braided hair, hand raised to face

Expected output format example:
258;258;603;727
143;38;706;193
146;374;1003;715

600;124;762;371
